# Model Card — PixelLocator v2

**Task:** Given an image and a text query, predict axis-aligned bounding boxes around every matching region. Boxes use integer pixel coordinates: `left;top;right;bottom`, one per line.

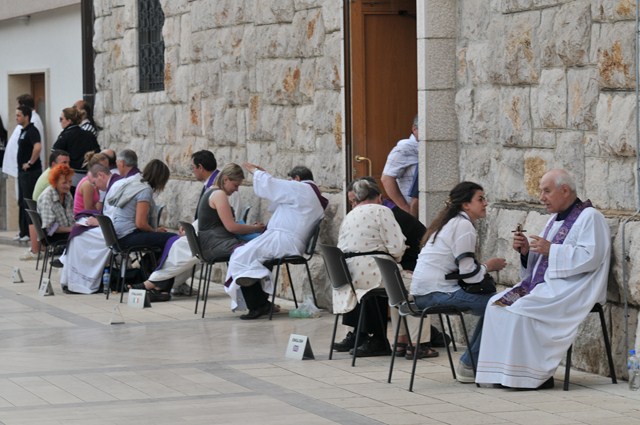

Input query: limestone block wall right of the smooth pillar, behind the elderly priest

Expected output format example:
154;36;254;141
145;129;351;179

455;0;640;374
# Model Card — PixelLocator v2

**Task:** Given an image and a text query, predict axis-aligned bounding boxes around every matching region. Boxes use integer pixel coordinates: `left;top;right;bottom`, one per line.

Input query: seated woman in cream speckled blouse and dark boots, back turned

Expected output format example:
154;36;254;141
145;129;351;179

333;179;405;357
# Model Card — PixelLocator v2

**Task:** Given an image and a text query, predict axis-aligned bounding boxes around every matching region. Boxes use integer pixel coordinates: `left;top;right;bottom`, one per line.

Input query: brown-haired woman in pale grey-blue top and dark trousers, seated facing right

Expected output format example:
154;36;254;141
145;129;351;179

104;159;177;284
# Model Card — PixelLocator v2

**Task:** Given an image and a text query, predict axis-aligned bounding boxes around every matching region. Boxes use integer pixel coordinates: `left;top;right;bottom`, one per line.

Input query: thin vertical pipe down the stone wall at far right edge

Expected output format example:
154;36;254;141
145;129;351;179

621;0;640;355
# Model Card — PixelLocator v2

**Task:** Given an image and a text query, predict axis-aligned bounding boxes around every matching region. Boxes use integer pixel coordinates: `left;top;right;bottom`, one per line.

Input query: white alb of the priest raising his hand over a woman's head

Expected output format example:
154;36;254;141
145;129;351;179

225;170;324;310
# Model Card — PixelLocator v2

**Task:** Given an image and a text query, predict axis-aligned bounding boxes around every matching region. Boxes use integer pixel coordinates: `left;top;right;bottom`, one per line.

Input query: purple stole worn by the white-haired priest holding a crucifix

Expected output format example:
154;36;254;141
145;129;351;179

496;199;592;306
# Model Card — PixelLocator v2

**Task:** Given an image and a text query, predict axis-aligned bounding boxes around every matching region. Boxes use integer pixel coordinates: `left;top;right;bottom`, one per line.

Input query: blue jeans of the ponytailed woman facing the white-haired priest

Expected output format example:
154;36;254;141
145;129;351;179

413;289;494;367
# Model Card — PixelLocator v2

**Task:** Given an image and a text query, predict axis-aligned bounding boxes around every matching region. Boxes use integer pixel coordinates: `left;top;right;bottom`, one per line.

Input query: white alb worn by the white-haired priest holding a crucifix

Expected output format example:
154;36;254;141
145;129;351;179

476;208;611;388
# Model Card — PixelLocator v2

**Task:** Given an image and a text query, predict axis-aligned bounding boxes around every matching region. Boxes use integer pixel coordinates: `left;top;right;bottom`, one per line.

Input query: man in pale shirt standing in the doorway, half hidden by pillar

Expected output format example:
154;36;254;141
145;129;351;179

381;115;418;213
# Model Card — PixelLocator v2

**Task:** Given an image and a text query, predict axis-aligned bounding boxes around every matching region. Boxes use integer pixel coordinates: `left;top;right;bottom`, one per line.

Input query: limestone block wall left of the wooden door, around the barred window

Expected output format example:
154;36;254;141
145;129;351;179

93;0;345;305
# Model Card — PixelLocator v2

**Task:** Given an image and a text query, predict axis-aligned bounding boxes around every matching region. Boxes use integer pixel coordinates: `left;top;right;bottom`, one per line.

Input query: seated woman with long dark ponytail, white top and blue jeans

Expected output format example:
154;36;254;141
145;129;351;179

411;182;506;383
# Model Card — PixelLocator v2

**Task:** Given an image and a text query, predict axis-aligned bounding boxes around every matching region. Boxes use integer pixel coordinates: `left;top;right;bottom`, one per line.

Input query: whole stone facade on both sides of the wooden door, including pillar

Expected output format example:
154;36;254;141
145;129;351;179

94;0;640;373
